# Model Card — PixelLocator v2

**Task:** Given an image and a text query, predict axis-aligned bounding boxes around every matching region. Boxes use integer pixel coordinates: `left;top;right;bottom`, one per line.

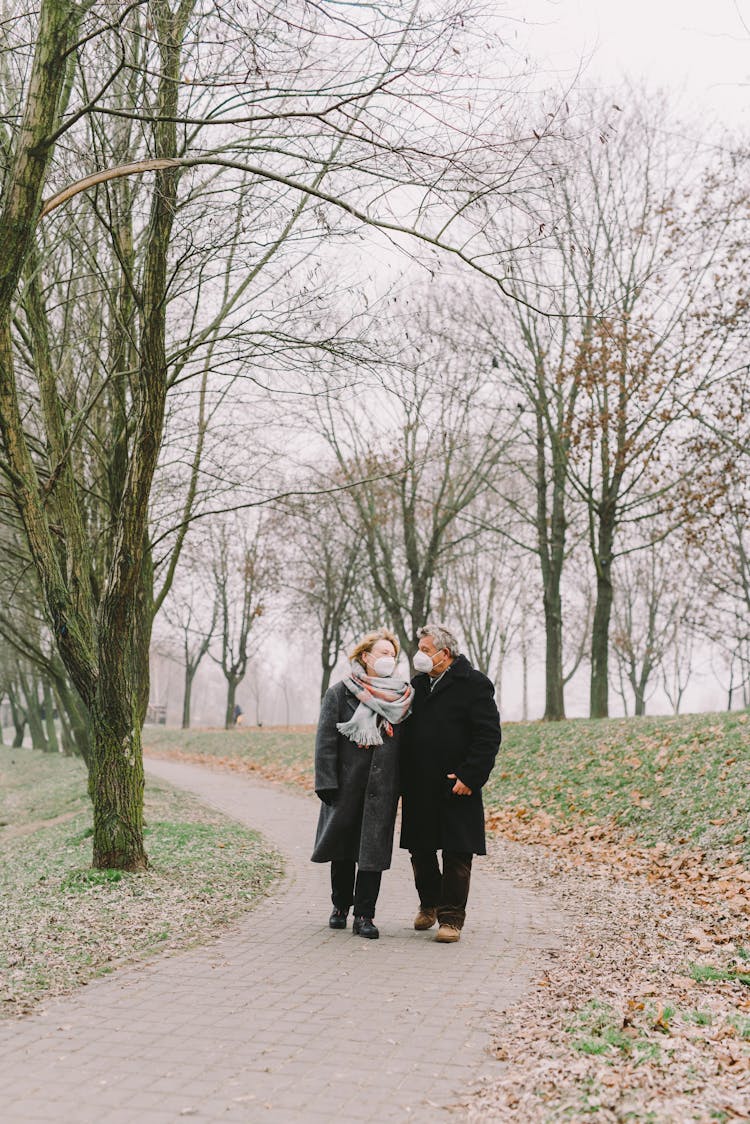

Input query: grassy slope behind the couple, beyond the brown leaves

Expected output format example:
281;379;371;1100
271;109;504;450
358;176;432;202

145;711;750;864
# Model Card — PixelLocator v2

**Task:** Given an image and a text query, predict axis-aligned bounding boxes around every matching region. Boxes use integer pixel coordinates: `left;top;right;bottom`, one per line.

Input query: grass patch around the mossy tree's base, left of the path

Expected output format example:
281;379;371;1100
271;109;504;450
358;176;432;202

0;747;281;1016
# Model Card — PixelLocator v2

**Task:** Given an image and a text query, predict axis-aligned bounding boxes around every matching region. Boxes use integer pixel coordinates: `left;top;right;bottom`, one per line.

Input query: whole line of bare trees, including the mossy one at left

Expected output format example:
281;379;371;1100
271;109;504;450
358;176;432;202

0;0;750;869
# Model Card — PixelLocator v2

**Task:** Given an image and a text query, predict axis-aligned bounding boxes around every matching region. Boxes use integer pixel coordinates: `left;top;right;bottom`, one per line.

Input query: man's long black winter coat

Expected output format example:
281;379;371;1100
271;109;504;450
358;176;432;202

401;655;500;854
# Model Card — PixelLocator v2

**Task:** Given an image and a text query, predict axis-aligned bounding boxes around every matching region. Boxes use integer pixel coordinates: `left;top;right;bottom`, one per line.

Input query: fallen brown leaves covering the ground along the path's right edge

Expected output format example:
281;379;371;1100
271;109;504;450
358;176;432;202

462;840;750;1124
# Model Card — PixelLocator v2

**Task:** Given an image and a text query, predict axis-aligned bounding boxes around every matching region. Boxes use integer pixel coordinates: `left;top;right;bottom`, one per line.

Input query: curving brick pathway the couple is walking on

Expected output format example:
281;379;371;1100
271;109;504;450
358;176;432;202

0;759;562;1124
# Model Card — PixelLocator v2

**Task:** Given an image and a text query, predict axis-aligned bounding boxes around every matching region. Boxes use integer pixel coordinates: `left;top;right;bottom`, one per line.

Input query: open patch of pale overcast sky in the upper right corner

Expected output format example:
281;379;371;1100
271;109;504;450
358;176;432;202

519;0;750;126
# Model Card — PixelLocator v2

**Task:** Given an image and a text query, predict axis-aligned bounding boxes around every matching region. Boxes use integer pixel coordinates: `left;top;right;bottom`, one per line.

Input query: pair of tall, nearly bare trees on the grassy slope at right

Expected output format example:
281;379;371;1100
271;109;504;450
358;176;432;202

485;94;746;717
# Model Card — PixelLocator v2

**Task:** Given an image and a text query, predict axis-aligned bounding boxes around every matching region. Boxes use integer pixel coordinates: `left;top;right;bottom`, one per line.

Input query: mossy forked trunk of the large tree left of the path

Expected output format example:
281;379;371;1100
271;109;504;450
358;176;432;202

0;0;193;870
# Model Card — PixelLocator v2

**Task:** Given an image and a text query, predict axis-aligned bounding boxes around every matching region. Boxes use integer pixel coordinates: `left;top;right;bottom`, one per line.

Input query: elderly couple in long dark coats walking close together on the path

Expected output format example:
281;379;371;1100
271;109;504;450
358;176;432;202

313;624;500;944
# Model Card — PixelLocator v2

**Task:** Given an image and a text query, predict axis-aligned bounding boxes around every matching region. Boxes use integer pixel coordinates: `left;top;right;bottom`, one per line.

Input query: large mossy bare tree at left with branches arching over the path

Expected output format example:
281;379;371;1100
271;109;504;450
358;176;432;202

0;0;550;869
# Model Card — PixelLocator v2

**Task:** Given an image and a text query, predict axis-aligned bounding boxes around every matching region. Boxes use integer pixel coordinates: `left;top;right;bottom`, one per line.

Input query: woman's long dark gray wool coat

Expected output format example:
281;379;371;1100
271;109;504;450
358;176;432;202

313;682;400;870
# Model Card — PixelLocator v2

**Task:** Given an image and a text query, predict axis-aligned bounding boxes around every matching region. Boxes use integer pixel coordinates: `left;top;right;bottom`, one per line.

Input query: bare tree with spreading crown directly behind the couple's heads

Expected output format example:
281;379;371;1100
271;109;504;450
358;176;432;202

317;302;514;658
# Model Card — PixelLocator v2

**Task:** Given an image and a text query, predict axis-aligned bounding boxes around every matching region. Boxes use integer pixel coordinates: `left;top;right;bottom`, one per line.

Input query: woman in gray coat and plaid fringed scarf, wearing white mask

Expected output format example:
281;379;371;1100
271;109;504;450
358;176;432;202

313;628;414;940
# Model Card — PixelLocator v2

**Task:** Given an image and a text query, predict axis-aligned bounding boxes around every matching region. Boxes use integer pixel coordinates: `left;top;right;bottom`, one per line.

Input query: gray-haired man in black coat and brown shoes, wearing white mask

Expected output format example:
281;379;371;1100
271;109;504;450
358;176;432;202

401;624;500;944
